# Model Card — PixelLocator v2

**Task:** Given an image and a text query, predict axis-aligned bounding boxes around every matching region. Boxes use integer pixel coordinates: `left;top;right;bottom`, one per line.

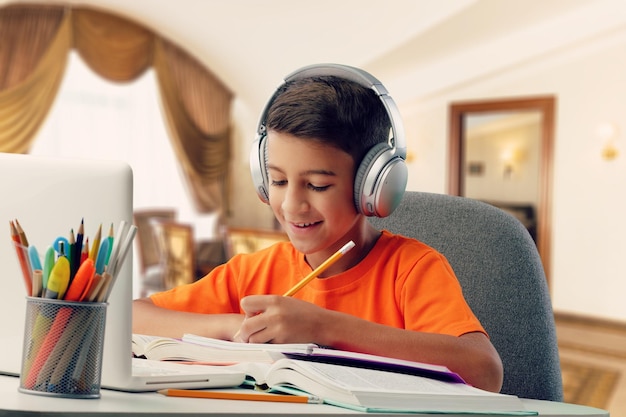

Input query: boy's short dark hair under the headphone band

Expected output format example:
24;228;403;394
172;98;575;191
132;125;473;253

265;76;391;166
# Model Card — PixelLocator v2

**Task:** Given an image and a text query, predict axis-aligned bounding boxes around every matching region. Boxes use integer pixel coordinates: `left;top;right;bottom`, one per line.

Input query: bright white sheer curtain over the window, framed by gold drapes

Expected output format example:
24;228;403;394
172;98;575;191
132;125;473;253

30;52;217;294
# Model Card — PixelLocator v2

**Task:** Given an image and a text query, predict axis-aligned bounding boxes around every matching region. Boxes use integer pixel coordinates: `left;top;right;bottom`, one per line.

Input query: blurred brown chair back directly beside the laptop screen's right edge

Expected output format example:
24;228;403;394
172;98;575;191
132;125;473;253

133;208;176;274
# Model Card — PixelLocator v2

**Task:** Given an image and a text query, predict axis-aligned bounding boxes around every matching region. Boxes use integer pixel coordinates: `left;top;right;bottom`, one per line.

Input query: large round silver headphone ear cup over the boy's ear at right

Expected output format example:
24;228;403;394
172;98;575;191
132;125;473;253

354;143;408;217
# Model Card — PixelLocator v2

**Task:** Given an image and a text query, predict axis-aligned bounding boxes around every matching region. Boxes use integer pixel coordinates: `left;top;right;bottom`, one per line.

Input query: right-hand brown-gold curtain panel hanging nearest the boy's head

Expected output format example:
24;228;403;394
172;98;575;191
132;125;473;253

154;39;232;208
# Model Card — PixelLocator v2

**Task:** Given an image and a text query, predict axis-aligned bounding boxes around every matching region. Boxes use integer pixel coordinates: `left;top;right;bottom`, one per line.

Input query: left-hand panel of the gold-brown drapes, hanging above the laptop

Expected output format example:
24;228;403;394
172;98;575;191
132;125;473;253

0;6;72;153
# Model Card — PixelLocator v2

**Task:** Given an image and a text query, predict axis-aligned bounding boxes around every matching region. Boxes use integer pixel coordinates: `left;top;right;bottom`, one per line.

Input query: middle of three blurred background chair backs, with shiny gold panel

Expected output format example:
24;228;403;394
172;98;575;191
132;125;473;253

156;221;197;290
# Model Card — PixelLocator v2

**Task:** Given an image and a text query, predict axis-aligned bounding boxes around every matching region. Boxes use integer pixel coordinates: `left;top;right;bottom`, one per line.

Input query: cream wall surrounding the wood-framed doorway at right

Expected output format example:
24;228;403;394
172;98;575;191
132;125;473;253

392;29;626;321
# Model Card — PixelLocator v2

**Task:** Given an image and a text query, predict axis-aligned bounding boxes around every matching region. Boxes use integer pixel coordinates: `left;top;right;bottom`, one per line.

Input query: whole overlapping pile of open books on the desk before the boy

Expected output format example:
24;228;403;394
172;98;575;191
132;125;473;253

133;335;537;415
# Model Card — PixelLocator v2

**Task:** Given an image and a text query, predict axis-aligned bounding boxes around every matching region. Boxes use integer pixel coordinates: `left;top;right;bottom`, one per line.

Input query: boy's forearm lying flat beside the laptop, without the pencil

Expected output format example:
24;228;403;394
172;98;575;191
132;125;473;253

133;298;243;340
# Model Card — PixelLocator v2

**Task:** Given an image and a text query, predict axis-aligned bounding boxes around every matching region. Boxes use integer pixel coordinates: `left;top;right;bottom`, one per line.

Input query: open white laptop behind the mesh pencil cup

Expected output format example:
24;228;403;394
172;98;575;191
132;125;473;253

0;153;245;391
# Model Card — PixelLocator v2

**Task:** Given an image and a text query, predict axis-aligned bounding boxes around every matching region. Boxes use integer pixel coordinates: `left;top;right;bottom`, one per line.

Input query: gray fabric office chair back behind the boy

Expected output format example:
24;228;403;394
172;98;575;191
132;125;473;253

370;192;563;401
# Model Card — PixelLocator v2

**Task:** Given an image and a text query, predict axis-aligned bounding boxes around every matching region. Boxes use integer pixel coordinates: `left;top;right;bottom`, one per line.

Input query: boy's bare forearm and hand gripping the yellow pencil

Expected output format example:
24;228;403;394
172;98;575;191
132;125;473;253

238;296;503;392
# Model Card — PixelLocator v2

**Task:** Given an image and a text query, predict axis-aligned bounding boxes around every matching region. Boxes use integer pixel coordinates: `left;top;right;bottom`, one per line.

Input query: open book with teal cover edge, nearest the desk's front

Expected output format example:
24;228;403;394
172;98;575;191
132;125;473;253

235;358;537;415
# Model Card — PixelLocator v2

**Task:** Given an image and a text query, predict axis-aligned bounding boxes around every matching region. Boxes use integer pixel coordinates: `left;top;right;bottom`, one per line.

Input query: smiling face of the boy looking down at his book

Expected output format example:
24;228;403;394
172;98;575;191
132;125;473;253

267;131;359;256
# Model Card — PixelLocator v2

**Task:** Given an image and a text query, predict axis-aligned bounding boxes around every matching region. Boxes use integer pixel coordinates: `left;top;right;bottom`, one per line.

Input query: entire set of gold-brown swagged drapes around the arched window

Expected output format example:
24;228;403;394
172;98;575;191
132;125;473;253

0;5;232;212
